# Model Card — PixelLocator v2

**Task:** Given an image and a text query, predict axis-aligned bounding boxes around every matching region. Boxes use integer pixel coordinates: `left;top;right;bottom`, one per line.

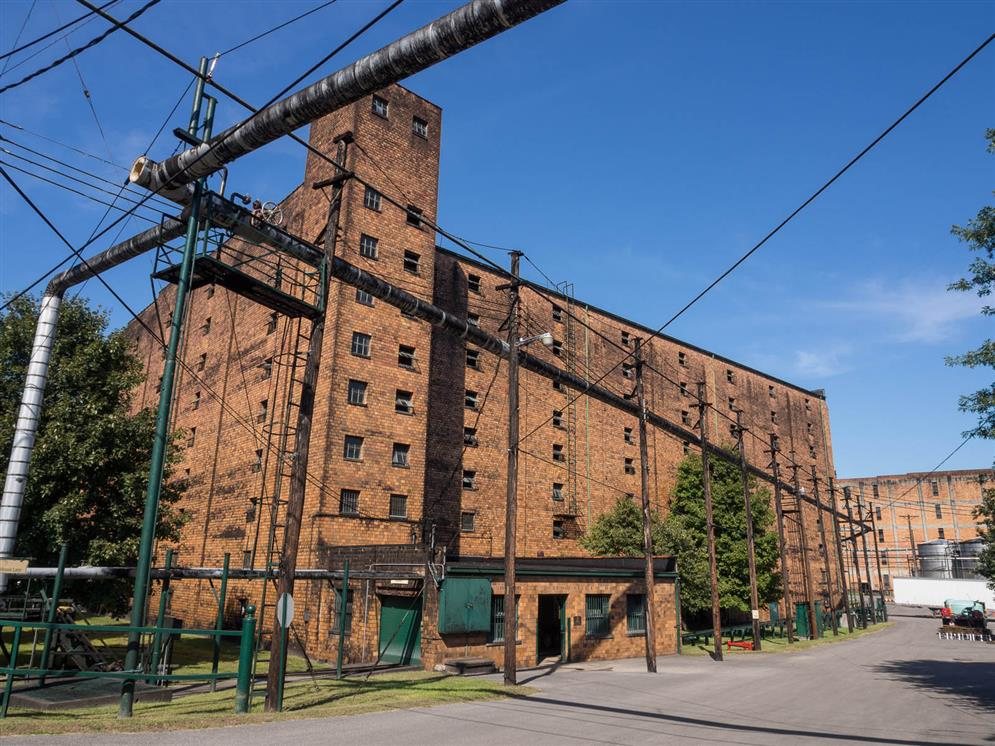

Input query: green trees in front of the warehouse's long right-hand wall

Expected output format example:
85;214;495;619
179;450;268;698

580;455;781;615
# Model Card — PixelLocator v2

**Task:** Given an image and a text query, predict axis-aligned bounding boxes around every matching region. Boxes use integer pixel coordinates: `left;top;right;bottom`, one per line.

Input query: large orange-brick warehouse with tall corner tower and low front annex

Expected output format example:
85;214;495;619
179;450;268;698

129;86;836;666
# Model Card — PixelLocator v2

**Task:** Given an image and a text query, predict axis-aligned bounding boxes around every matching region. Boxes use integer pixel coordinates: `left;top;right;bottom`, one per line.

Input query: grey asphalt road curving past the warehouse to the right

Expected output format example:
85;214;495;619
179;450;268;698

9;617;995;746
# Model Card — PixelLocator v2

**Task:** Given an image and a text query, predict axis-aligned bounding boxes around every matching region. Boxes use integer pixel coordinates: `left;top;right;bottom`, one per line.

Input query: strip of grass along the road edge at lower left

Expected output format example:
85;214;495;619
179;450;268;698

0;672;533;736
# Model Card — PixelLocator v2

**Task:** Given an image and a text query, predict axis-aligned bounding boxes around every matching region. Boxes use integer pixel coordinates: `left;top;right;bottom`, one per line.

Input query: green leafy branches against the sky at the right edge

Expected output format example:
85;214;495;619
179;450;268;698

947;129;995;438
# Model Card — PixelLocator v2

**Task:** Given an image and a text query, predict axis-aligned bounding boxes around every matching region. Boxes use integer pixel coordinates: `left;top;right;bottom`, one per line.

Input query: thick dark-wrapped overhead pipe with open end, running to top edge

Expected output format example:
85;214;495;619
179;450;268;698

131;0;563;203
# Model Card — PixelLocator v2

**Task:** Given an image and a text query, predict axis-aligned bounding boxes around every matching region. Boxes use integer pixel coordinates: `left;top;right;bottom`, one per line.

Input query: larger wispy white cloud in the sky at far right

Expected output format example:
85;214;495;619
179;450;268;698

820;279;984;344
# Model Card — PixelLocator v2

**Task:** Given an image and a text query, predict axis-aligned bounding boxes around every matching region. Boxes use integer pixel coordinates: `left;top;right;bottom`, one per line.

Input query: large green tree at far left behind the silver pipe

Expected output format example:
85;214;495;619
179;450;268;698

0;297;183;613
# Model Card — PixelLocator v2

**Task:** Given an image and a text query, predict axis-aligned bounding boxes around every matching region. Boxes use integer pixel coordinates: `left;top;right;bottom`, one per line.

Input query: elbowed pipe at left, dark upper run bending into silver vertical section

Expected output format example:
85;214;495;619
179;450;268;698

0;218;186;593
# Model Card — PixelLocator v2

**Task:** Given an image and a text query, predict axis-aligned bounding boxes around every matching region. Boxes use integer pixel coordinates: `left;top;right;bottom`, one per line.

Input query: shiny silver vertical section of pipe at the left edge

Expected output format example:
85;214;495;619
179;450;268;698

0;290;62;593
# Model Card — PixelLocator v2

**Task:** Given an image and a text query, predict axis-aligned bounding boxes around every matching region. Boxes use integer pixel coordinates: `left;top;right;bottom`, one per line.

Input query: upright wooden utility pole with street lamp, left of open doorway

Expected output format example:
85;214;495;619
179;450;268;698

504;251;522;686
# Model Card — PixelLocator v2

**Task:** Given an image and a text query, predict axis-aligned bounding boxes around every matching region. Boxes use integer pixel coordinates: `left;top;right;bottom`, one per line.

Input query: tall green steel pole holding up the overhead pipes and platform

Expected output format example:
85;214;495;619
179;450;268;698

118;58;207;718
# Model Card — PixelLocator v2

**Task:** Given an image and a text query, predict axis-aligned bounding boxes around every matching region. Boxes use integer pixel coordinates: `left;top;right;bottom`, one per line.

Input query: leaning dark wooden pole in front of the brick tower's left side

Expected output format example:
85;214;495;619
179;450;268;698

265;132;353;712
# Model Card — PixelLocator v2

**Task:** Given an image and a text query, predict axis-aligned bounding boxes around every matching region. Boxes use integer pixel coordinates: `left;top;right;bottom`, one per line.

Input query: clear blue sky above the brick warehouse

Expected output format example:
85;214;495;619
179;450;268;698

0;0;995;476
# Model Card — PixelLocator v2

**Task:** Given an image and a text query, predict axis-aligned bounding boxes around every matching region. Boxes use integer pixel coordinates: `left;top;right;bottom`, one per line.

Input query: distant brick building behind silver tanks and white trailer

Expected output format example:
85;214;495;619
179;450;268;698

839;469;995;597
